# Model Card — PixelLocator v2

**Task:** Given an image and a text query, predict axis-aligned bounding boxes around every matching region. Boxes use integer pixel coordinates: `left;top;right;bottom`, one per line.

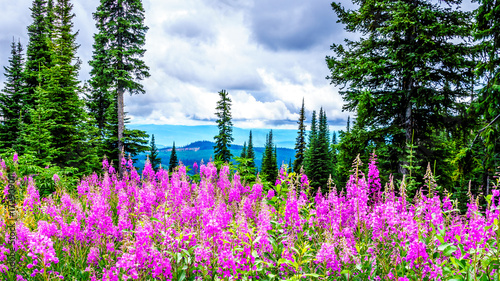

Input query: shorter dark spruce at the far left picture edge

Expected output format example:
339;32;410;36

0;40;24;150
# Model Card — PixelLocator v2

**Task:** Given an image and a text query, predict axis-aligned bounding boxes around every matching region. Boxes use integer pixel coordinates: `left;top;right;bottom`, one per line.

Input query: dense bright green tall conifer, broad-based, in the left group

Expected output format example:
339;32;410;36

23;0;97;172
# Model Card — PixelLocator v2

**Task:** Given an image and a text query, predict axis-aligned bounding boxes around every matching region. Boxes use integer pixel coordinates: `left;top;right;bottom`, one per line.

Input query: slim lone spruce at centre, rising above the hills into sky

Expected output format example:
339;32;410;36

214;90;234;163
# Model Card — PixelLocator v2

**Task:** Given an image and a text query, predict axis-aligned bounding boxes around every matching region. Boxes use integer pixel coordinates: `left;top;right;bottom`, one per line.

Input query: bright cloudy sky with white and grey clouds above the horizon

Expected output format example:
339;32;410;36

0;0;476;130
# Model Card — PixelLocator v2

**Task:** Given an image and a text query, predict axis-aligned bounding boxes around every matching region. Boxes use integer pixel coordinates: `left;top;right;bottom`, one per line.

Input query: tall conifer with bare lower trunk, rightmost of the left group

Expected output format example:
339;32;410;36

89;0;149;175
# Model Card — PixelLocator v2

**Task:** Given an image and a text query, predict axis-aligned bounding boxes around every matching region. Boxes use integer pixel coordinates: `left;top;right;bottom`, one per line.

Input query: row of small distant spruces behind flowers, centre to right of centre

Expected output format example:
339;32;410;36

207;90;338;190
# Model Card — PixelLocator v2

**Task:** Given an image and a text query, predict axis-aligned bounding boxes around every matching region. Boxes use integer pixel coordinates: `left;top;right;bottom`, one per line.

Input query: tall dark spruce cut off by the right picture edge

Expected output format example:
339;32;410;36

466;0;500;194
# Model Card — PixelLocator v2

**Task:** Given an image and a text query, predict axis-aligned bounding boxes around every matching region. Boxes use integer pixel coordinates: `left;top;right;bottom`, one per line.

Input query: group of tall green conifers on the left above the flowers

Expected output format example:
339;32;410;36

0;0;149;174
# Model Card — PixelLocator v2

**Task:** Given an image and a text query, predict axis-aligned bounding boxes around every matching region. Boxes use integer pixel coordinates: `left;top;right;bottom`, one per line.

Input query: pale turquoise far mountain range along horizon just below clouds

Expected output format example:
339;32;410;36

127;124;297;149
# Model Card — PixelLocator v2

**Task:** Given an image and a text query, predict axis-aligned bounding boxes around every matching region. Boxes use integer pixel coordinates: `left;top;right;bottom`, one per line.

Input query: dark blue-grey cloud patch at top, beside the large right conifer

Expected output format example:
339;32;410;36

249;0;341;50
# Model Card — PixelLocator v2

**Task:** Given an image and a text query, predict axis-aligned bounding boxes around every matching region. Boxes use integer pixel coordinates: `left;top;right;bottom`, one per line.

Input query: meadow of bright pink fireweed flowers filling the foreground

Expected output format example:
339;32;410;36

0;153;500;281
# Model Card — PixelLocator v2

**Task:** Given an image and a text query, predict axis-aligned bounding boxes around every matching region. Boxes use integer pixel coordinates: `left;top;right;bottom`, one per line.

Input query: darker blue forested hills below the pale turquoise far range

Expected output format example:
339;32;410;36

135;139;295;172
